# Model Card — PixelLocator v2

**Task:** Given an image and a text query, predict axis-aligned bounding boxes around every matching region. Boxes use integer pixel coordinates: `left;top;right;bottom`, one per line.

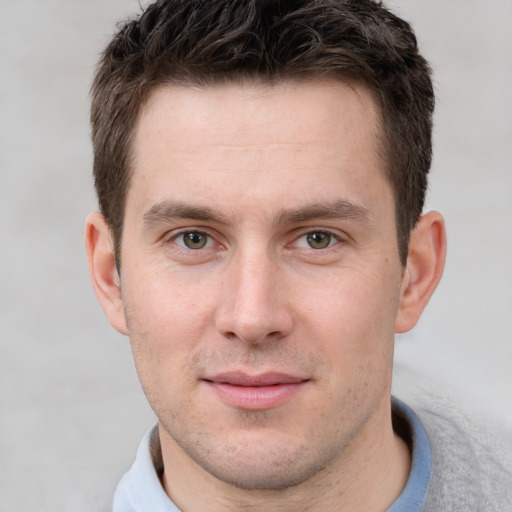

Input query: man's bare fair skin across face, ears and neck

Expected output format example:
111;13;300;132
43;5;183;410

86;81;446;511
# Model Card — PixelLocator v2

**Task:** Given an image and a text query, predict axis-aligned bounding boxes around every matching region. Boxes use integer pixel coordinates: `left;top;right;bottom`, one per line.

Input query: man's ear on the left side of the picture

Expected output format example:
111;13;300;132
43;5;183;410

85;212;127;334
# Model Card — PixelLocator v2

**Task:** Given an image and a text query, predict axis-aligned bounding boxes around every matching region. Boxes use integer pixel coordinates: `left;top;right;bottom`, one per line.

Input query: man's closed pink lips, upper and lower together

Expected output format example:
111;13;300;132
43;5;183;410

203;372;309;411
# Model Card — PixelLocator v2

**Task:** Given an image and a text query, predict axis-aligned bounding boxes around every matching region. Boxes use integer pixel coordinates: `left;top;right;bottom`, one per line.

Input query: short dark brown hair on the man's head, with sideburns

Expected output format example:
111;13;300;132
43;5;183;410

91;0;434;265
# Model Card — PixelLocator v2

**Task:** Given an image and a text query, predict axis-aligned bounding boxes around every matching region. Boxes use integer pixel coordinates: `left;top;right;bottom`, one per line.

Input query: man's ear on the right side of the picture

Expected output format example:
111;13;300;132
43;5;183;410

395;212;446;332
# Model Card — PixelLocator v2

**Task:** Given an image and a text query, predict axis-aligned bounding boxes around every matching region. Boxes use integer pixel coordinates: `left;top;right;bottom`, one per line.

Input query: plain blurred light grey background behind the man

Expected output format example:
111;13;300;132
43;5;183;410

0;0;512;512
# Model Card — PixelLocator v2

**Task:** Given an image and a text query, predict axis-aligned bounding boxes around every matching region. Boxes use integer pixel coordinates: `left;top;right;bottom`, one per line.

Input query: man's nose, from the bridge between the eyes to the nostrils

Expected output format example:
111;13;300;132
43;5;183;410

215;248;293;344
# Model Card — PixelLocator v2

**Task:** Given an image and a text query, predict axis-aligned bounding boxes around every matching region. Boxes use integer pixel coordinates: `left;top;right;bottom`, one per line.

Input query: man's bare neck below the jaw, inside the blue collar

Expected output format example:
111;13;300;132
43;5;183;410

160;400;411;512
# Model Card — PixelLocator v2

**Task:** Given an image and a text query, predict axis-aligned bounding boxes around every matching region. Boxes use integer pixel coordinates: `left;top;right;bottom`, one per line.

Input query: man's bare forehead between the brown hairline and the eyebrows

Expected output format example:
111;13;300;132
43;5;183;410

127;80;384;222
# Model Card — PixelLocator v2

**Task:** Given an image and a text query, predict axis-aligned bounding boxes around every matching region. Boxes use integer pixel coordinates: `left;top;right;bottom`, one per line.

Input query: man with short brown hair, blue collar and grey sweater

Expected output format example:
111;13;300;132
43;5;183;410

86;0;507;512
